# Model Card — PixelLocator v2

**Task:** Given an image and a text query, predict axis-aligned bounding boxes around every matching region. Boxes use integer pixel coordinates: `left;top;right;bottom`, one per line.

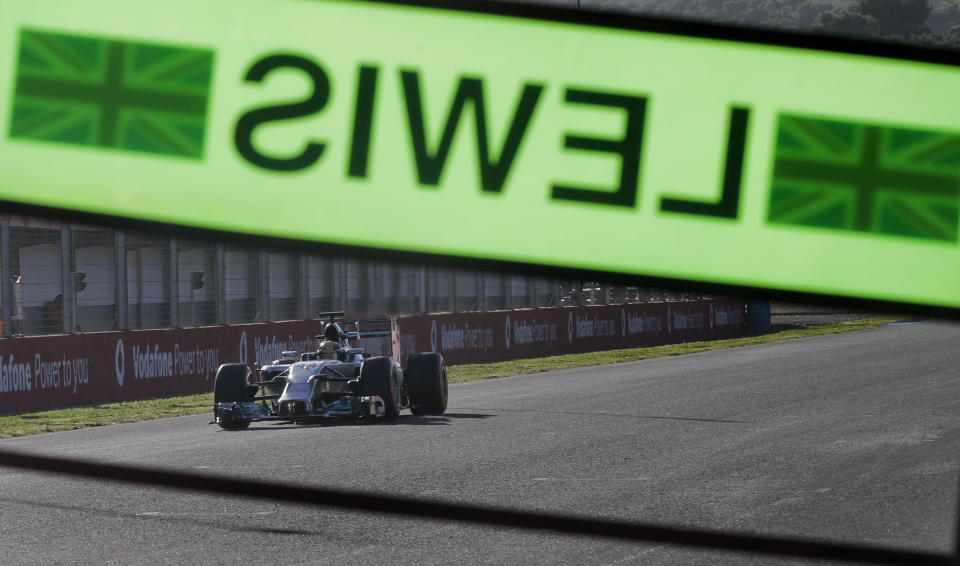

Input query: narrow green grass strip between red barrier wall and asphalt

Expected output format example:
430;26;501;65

0;317;897;438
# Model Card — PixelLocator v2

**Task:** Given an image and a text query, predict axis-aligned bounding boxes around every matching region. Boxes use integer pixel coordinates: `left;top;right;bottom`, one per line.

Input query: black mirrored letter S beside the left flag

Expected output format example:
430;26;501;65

234;54;330;171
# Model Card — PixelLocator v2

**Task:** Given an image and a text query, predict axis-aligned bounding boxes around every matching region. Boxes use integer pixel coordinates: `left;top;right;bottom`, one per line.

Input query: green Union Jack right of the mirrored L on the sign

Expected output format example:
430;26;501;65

768;115;960;241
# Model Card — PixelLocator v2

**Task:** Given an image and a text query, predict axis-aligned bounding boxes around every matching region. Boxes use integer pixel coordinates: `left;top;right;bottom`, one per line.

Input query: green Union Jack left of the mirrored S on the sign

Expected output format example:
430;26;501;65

10;30;213;159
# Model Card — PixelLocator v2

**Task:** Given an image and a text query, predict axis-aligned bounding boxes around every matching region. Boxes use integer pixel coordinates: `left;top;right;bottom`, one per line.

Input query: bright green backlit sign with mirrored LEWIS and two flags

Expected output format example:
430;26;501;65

0;0;960;308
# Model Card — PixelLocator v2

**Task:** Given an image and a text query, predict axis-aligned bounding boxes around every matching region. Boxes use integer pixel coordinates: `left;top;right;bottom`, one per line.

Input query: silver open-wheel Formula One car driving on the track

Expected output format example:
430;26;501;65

213;312;447;430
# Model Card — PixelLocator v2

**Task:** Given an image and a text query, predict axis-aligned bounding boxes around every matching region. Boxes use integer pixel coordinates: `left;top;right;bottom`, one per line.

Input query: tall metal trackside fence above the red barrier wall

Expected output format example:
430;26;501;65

0;216;699;336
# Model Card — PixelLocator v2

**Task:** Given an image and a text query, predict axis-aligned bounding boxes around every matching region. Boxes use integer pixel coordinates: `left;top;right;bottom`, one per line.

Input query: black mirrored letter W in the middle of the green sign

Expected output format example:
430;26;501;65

400;71;543;192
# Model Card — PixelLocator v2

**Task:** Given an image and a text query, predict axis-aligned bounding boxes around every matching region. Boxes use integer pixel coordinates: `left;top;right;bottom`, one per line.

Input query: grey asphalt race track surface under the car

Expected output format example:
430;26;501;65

0;322;960;565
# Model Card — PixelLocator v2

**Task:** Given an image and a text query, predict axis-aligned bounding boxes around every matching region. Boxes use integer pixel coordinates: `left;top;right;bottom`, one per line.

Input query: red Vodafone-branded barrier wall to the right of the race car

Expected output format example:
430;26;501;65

393;299;744;364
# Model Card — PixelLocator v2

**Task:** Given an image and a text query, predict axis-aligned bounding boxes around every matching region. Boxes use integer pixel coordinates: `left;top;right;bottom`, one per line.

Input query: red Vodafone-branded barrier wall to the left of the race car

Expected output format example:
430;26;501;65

0;320;390;412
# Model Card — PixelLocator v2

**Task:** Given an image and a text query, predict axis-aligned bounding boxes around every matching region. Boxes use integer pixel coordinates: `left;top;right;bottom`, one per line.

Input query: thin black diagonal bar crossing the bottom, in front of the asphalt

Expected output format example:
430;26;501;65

0;450;957;566
